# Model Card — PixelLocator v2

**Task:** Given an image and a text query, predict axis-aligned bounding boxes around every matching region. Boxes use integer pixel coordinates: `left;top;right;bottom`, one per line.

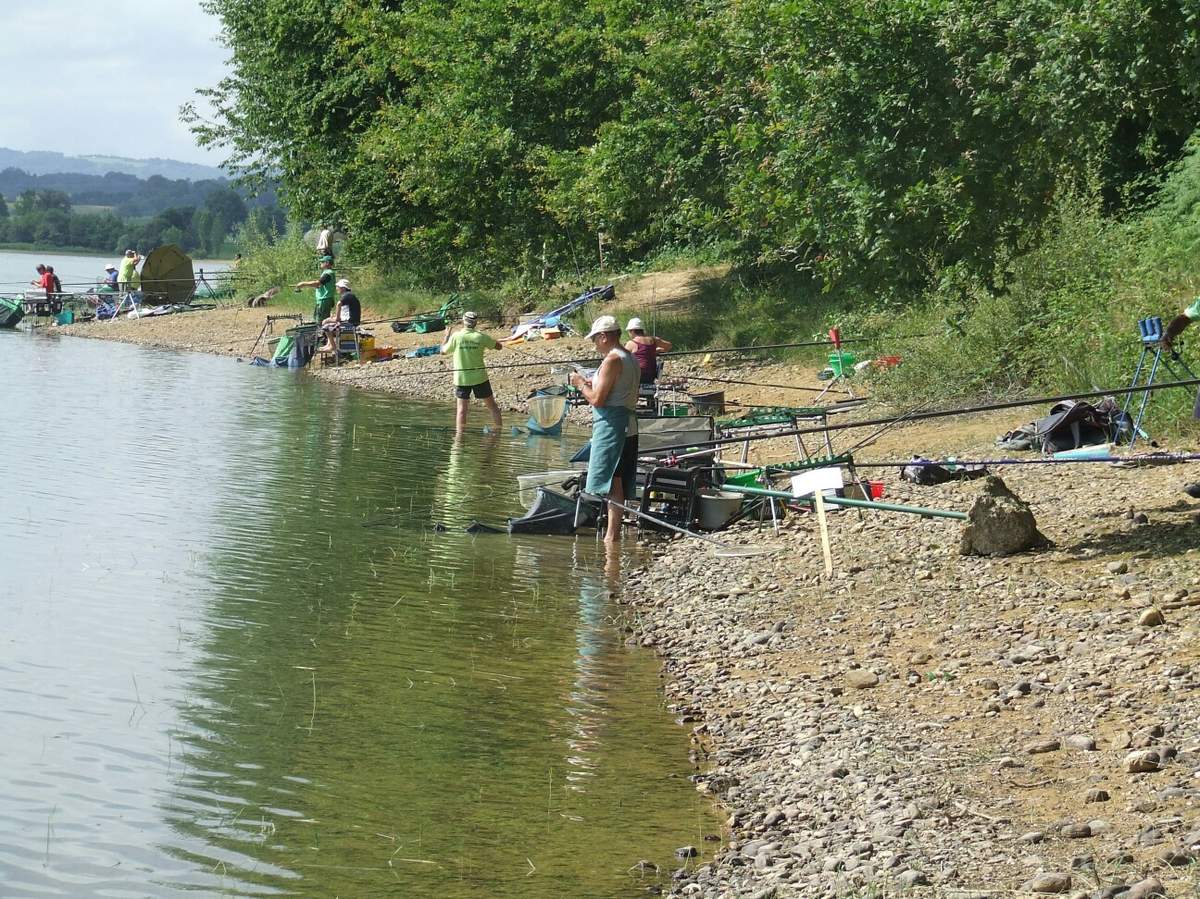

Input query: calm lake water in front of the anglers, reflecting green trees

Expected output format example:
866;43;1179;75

0;331;719;899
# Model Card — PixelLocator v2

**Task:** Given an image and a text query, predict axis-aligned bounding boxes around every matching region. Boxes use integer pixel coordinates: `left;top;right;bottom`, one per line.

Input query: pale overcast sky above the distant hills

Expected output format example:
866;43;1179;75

0;0;228;166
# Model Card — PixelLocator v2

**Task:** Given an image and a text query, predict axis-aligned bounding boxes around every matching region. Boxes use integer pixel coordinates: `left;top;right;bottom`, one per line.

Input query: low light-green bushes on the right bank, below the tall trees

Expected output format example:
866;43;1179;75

864;137;1200;421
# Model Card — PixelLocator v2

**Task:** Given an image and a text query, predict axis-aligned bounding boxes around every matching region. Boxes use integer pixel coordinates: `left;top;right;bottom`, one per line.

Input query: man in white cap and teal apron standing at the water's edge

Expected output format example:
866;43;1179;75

571;316;638;543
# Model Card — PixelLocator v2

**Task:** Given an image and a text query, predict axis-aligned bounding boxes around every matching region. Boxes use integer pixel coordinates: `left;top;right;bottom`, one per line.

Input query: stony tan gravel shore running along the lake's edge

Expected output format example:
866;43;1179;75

51;310;1200;899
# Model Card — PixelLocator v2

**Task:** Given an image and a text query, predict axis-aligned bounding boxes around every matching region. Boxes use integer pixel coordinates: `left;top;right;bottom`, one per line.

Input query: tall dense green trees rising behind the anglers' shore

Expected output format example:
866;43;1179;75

188;0;1200;293
